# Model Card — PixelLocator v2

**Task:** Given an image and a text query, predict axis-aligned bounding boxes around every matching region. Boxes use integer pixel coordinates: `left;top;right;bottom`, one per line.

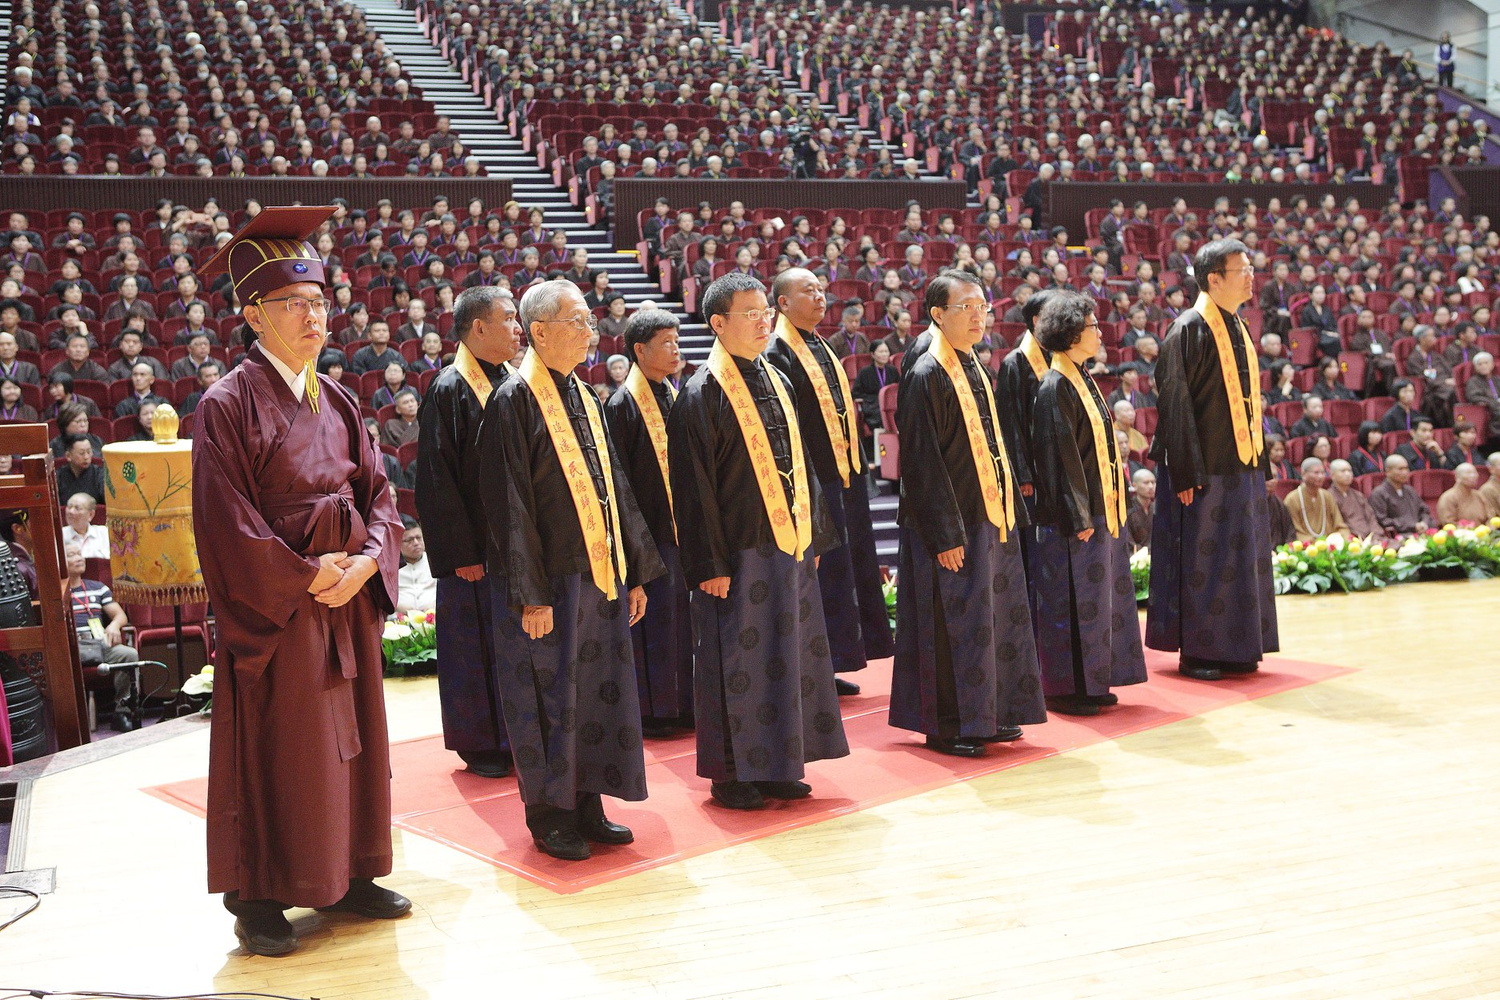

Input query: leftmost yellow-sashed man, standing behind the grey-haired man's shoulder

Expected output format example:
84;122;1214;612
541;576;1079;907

414;285;521;778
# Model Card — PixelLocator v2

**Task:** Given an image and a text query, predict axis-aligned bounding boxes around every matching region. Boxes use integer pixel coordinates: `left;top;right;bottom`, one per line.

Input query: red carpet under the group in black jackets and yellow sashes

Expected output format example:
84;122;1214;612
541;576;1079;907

147;649;1352;892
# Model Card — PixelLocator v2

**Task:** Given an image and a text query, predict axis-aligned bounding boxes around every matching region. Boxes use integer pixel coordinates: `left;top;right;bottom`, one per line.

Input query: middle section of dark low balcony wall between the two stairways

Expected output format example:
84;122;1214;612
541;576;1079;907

615;177;968;250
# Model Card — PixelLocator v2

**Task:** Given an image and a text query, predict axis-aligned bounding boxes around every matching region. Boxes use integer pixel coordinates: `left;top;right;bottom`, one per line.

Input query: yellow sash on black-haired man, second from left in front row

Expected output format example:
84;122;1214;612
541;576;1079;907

708;340;813;562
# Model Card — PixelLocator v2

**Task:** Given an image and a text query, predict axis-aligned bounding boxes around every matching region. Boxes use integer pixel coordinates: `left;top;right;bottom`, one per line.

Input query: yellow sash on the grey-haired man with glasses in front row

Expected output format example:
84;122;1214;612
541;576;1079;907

521;351;626;600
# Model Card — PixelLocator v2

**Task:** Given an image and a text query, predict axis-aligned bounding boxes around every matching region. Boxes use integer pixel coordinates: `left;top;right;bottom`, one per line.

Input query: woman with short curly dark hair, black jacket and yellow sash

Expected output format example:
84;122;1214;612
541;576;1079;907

1028;292;1146;715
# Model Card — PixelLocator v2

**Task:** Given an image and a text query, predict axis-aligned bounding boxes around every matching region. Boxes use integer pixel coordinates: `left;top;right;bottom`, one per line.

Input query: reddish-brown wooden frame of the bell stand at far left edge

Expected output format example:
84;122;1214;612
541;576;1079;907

0;424;89;750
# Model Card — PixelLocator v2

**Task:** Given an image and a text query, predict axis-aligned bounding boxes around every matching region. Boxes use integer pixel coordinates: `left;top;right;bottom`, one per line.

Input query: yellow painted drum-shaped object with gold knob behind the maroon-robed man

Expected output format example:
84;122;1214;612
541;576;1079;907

104;406;209;606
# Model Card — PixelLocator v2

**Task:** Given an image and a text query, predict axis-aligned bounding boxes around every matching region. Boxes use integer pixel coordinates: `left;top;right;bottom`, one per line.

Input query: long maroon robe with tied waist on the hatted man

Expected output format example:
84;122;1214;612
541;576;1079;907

194;345;402;907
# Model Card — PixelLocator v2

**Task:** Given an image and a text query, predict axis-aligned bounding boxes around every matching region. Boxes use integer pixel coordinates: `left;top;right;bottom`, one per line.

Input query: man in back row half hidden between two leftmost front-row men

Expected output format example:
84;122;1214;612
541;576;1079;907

605;309;693;738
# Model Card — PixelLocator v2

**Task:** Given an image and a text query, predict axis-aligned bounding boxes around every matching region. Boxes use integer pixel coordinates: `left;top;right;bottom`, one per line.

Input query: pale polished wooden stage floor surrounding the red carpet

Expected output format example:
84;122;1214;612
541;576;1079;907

0;580;1500;1000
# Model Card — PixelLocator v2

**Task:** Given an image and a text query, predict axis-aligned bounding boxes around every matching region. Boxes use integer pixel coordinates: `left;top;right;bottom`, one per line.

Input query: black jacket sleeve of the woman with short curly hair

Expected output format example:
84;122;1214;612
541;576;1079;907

1034;372;1113;534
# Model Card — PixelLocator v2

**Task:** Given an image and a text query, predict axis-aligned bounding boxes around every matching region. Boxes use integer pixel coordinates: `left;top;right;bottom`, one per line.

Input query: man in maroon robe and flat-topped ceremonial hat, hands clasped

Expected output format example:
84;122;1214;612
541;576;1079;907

194;207;411;955
